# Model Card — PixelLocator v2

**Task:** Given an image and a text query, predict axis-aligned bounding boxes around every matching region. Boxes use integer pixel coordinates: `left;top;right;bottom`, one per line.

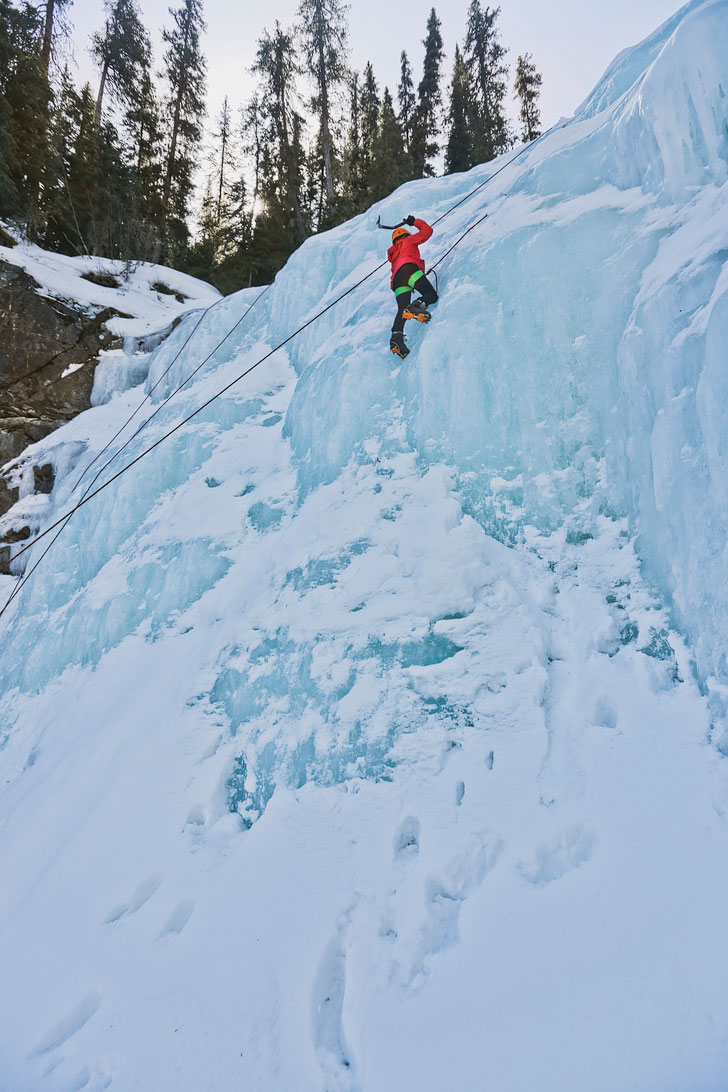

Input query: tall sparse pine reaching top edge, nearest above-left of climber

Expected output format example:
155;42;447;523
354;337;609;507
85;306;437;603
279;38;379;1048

298;0;348;219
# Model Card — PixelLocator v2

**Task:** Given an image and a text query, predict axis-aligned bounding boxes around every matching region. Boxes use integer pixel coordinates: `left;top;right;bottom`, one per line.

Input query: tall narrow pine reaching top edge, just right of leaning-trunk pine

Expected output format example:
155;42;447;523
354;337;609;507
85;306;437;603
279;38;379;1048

162;0;205;253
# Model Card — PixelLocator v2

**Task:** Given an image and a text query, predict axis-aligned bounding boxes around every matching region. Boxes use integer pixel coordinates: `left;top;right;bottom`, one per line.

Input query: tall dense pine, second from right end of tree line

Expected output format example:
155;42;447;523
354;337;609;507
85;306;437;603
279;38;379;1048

465;0;511;163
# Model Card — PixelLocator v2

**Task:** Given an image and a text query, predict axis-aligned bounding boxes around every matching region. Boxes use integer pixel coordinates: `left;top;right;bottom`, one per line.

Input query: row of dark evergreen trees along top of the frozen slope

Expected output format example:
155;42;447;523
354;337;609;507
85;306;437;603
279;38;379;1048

0;0;541;290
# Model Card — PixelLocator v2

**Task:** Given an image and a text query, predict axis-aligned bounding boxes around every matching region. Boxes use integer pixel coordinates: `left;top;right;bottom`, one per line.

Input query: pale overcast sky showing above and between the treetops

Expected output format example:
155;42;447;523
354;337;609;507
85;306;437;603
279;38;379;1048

64;0;680;128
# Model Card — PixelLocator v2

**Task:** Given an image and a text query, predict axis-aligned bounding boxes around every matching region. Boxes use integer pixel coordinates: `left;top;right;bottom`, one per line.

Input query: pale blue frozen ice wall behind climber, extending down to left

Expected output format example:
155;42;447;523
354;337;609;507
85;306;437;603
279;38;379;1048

2;0;728;686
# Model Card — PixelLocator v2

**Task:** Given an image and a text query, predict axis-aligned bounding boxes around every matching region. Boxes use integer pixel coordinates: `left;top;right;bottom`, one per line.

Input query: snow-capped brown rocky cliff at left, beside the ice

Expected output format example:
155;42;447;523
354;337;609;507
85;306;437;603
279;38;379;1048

0;242;220;572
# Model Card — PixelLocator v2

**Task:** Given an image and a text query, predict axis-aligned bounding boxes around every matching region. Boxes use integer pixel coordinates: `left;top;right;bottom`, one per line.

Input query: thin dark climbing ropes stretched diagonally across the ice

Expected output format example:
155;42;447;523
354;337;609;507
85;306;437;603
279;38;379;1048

0;126;558;618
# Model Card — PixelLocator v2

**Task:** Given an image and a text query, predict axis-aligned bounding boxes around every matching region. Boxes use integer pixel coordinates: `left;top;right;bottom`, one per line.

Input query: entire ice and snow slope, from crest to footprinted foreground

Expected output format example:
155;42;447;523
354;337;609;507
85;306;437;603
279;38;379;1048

0;0;728;1092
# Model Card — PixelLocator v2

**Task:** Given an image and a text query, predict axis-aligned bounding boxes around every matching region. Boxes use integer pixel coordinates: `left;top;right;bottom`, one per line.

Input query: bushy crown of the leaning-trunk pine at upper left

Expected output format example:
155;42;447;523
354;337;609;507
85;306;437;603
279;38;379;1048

91;0;152;126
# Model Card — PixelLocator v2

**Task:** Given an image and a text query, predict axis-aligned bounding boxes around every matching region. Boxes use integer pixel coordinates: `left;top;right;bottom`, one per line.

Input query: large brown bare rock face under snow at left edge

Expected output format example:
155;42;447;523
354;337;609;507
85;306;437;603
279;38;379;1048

0;261;118;467
